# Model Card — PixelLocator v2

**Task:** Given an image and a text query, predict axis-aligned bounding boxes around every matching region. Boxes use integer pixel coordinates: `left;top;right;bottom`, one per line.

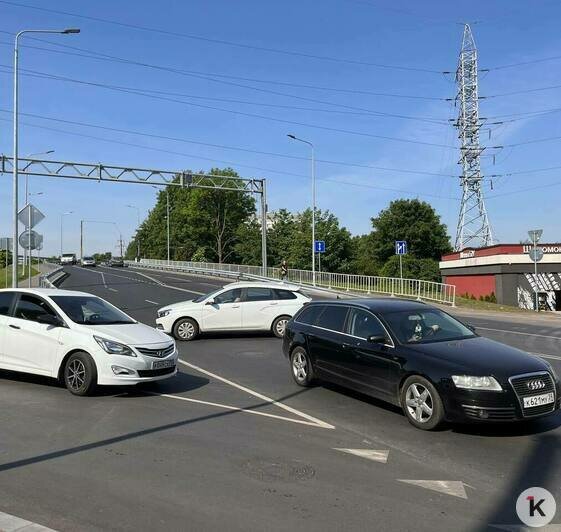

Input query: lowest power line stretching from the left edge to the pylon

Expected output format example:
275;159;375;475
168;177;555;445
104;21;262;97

0;118;458;200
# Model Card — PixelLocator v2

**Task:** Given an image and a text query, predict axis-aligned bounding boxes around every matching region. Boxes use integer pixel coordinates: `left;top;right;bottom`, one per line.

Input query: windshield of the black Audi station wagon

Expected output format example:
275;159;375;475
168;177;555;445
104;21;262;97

382;309;475;344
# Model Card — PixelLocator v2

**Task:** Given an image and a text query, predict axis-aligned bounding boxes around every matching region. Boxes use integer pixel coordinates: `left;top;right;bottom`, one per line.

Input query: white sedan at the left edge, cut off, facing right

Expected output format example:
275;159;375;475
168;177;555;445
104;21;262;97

0;289;177;395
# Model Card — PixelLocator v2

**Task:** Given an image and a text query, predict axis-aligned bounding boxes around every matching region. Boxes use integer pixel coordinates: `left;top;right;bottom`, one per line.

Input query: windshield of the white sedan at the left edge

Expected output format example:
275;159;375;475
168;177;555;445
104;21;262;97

52;296;136;325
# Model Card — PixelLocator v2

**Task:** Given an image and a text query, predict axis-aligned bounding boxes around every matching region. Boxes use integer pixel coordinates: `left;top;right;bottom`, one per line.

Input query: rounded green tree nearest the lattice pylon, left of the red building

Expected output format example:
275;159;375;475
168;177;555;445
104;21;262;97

371;199;452;263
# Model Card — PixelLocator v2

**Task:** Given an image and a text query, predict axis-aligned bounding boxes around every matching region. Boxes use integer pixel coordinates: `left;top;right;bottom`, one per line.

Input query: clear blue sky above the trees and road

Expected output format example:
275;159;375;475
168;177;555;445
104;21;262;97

0;0;561;255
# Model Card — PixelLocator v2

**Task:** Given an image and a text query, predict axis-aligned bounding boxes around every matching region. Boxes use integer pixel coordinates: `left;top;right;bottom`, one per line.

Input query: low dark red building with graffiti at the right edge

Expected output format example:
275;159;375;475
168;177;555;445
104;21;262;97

440;244;561;311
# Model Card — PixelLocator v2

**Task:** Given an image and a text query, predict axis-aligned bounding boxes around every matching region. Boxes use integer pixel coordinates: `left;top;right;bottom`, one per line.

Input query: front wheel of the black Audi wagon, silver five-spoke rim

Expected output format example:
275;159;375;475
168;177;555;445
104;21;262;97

401;375;444;430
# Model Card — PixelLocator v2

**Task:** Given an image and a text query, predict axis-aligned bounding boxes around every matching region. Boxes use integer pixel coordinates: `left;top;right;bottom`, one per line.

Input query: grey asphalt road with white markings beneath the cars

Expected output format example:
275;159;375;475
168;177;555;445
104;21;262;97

0;267;561;531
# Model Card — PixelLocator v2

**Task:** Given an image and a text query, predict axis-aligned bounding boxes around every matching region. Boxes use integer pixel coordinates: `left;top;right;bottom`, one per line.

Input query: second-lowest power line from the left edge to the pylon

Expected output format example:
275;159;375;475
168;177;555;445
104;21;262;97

0;109;457;177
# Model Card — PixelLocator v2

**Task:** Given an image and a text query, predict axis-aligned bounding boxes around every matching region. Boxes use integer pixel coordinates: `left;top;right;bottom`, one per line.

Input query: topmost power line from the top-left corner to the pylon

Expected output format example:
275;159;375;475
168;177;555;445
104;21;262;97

0;0;442;74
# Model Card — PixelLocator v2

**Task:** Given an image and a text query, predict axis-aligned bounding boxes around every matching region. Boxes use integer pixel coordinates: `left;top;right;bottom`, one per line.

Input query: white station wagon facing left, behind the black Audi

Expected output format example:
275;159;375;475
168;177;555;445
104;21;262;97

156;282;310;341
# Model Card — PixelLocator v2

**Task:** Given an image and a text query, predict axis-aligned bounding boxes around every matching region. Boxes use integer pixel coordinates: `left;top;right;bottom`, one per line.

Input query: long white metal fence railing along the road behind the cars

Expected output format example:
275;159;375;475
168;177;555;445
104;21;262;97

132;259;456;306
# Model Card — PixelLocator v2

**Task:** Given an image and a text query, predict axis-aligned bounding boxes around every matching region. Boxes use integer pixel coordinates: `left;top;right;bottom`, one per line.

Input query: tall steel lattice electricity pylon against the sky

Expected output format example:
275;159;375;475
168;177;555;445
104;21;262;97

454;24;493;251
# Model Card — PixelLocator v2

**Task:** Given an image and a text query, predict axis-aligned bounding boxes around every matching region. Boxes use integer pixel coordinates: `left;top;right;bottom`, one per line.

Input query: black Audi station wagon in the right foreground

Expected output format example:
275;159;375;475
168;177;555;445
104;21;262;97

283;298;560;430
